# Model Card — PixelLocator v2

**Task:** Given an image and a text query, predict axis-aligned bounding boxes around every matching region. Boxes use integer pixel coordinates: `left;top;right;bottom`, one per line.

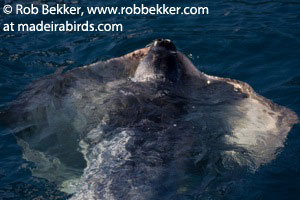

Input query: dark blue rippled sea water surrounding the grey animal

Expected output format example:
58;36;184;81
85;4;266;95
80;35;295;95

0;0;300;200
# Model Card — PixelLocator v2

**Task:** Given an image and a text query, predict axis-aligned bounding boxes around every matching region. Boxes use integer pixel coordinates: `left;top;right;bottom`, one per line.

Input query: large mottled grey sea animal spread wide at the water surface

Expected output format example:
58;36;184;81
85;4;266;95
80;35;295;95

1;39;298;200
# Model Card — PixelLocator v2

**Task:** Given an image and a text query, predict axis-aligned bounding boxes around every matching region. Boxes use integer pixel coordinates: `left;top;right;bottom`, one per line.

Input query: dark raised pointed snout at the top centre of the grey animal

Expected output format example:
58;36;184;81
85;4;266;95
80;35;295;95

134;39;180;82
